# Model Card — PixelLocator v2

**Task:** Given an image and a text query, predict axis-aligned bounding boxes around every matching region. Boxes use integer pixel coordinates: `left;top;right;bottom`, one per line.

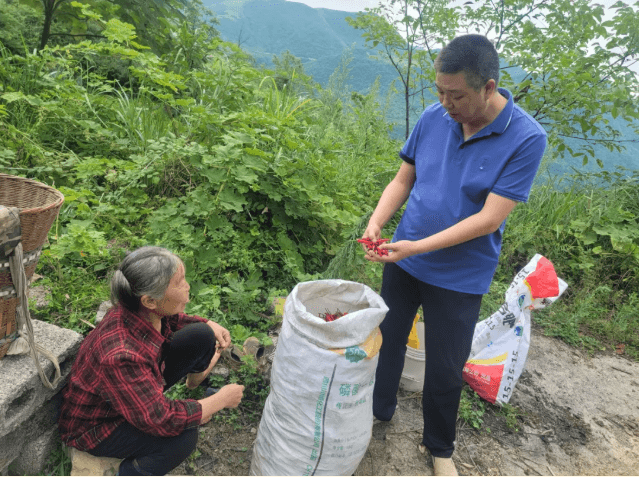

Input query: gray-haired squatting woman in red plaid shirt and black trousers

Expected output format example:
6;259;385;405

59;247;244;475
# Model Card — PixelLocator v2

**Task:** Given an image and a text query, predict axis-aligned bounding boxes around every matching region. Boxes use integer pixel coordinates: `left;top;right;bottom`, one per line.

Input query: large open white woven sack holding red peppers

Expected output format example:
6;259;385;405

250;280;388;475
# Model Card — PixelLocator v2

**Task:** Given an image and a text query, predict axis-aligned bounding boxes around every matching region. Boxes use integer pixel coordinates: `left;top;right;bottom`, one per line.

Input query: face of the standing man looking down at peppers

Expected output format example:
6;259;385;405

435;72;494;126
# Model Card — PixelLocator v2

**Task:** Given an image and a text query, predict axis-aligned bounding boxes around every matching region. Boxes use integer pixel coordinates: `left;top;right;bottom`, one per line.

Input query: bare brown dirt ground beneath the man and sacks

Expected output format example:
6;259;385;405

172;322;639;475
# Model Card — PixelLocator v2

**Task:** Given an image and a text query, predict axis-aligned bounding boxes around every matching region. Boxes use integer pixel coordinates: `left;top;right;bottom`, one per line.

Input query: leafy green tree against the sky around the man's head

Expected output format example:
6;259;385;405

351;0;639;166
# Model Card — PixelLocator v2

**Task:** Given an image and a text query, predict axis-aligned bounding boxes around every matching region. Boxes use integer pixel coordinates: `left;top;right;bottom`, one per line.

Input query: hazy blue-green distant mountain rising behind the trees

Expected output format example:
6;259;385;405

203;0;639;173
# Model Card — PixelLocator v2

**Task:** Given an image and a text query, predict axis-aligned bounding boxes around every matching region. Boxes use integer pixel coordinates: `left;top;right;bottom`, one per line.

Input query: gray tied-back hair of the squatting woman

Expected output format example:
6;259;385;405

111;247;182;313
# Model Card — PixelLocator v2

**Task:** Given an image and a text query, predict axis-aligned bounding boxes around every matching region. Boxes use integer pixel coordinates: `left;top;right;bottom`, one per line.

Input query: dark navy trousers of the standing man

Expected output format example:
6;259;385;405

373;263;482;457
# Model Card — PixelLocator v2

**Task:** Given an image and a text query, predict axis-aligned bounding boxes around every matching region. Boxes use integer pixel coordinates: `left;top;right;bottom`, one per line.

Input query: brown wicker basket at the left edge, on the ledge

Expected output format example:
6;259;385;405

0;174;64;359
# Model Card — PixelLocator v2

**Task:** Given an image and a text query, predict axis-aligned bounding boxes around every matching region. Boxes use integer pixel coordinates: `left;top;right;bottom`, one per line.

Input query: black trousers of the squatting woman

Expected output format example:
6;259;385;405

89;323;215;475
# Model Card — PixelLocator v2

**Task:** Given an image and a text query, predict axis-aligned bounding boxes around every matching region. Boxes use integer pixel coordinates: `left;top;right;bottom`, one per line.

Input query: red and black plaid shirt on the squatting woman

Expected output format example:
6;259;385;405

58;305;207;451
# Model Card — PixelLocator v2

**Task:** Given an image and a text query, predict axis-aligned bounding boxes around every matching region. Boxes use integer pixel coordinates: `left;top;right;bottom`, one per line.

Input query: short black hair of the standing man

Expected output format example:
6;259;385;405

435;35;499;91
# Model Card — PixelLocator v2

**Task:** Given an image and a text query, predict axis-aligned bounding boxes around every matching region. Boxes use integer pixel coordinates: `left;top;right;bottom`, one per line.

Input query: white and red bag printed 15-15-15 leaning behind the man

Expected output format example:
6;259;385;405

463;254;568;404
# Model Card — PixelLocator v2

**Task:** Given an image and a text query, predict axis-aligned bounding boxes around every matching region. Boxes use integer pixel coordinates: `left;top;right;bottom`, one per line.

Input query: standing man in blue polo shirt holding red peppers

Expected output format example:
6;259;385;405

363;35;546;475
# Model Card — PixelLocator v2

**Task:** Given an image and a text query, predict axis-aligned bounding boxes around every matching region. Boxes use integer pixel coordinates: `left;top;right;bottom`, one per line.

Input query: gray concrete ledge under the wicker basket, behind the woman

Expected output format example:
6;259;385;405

0;320;84;475
